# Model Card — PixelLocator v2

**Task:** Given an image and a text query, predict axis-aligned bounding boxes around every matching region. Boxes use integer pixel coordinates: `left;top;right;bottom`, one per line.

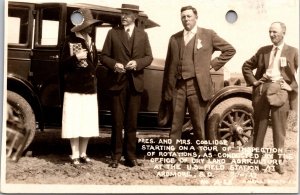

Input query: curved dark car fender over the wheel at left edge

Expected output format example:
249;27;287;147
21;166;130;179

7;73;44;129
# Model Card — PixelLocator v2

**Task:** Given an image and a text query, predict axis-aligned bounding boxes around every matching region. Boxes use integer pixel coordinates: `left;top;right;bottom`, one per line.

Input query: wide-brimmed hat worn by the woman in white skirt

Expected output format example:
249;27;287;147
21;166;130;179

70;9;100;32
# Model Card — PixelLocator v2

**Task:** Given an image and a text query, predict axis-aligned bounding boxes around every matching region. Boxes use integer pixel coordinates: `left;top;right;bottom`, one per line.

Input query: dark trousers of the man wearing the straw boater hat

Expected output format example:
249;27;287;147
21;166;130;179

111;79;141;160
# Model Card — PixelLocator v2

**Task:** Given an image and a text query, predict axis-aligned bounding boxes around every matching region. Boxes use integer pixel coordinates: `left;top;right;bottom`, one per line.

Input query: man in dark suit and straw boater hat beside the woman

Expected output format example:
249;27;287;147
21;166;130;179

101;4;153;168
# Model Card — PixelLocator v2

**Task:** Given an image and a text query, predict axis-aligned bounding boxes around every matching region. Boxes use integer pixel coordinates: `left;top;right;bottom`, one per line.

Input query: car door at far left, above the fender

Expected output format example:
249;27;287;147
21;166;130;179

5;2;34;81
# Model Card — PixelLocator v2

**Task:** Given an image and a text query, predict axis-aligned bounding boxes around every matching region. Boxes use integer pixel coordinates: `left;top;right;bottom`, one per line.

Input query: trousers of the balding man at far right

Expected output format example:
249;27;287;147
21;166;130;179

253;83;289;160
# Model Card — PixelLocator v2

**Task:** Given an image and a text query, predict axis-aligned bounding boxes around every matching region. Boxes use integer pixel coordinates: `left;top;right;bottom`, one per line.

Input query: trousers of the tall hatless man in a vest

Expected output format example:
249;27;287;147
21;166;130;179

170;78;207;151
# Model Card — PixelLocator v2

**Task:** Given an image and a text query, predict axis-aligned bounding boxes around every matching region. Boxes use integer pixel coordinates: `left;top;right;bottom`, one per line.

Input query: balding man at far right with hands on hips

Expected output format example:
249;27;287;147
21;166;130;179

242;22;298;174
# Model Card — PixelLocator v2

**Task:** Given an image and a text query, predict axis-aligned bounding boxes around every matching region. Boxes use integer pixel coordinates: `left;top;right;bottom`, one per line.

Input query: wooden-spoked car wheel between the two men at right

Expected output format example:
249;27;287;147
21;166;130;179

206;97;254;148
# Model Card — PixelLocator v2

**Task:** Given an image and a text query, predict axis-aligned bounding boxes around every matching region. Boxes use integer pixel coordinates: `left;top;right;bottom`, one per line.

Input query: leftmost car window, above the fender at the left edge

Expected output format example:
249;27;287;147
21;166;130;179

7;7;29;44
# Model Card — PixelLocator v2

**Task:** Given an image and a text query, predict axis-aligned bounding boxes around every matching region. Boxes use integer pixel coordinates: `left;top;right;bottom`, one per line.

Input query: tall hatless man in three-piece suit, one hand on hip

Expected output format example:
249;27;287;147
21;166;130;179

162;6;235;158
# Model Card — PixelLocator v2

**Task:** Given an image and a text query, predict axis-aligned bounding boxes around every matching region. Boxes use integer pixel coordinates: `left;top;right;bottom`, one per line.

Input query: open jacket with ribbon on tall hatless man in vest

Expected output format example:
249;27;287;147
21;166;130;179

162;27;235;101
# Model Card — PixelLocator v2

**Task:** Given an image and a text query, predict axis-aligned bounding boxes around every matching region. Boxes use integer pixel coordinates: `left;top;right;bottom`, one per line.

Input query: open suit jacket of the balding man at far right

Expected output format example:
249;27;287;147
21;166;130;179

242;44;298;109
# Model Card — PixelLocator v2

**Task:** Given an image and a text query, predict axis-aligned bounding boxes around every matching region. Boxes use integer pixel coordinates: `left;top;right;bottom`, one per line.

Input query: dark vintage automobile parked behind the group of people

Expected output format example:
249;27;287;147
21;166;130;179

6;1;253;151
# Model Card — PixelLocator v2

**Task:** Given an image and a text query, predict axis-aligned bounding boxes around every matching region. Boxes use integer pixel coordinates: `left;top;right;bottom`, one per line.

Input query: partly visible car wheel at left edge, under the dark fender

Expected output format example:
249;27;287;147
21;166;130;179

7;91;36;150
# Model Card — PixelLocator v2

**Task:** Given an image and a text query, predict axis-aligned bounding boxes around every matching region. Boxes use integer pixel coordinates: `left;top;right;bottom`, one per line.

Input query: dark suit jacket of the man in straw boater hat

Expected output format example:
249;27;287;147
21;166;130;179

101;27;153;92
